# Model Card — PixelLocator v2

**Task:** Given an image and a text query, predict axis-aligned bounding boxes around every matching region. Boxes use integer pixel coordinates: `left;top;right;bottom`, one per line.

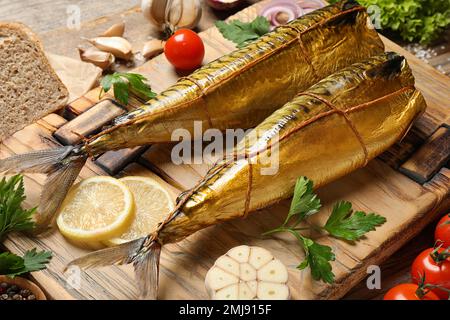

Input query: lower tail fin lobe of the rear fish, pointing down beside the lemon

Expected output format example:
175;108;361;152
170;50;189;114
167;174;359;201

34;157;86;233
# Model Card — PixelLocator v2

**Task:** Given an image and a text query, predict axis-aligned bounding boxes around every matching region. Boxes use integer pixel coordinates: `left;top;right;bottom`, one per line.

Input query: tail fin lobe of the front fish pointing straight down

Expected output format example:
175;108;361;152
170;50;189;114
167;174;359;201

133;241;161;300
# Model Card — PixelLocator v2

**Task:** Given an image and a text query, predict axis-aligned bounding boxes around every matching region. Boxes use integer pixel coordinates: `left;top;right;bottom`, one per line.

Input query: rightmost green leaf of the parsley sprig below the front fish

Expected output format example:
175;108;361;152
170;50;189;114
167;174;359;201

324;201;386;241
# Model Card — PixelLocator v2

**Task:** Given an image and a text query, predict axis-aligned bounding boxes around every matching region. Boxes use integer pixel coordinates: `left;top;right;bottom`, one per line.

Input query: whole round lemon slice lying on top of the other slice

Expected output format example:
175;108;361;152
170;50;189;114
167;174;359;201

56;176;134;241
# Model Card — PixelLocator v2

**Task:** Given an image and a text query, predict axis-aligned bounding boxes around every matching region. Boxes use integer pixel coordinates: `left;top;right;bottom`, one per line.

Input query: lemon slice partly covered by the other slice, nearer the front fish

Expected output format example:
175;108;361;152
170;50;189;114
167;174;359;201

104;176;175;246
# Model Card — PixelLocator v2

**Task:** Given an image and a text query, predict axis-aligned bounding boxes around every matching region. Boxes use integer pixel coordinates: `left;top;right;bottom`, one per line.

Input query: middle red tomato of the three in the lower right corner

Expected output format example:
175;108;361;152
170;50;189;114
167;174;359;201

411;248;450;299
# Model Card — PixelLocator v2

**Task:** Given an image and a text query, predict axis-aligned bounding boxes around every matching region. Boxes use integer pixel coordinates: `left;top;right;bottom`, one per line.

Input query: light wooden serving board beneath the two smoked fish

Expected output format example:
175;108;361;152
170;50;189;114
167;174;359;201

0;3;450;299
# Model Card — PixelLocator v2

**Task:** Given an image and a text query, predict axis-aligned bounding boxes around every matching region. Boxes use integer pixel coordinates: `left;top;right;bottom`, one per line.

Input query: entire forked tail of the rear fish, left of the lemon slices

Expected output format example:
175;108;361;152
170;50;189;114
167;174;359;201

0;146;87;233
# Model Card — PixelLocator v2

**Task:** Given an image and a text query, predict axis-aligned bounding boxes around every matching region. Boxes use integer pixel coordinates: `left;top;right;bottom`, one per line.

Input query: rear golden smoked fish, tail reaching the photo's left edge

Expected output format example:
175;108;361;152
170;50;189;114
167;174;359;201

0;0;384;231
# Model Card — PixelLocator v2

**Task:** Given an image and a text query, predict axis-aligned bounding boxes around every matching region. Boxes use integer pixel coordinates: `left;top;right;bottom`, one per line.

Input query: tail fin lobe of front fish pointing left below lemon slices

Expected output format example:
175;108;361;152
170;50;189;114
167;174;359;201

64;238;146;271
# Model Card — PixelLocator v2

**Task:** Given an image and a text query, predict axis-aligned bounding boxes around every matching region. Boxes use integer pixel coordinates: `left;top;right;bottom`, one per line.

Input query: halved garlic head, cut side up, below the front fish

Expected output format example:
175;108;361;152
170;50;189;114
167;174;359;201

205;246;289;300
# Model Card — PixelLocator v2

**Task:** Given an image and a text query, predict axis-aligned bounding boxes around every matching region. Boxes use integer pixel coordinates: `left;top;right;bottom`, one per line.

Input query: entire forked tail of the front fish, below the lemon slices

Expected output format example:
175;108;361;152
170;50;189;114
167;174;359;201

66;237;161;300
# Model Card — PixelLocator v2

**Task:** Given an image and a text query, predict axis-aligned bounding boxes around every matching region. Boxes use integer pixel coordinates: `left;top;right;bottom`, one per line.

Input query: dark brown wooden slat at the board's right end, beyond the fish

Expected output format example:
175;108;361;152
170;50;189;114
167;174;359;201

400;127;450;183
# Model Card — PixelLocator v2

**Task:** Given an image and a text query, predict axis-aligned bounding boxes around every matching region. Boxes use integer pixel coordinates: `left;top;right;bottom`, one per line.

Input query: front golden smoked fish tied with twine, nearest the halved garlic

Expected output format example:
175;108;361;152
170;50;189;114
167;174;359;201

70;52;426;298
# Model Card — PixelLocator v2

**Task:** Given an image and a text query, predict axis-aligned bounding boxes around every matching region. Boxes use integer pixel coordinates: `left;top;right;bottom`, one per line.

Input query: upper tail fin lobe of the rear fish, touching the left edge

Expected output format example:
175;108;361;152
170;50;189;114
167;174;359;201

0;146;75;174
